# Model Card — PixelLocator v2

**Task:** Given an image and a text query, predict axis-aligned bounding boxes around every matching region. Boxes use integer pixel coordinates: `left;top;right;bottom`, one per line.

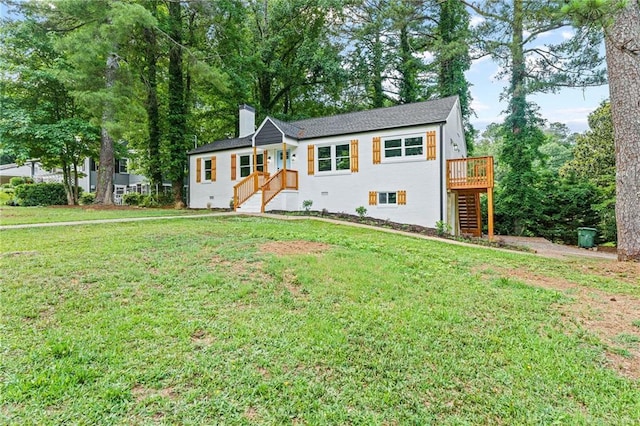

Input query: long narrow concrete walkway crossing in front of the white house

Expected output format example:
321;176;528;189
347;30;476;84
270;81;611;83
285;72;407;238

0;212;617;260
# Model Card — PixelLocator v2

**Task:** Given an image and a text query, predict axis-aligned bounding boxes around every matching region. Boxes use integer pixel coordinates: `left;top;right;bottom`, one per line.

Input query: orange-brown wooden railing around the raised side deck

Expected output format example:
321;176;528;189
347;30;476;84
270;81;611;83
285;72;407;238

447;157;493;189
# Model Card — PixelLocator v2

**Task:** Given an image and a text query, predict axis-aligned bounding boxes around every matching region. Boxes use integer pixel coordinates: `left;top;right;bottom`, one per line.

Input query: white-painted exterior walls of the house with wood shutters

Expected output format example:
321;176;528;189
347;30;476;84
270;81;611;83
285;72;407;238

189;107;466;227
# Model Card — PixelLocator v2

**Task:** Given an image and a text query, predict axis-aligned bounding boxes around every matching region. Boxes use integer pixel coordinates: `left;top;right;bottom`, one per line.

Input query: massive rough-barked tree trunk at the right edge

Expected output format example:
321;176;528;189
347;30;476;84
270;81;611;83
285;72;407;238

605;1;640;261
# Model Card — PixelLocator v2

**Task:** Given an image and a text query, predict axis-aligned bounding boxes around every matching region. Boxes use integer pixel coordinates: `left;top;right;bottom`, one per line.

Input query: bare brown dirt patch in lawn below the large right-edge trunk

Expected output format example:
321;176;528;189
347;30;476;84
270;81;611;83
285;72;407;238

478;262;640;379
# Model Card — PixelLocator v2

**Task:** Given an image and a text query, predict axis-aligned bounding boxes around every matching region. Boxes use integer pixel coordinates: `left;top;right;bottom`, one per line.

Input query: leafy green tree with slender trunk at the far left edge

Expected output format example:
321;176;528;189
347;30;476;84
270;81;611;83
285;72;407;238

0;13;98;204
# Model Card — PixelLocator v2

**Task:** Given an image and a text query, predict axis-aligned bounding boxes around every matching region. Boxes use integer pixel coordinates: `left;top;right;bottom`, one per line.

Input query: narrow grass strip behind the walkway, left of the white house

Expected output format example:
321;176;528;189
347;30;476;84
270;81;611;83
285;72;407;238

0;206;211;225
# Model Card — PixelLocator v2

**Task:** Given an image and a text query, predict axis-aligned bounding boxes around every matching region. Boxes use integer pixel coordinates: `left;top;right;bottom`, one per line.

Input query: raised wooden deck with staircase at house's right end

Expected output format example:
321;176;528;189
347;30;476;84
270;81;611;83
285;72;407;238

447;157;493;239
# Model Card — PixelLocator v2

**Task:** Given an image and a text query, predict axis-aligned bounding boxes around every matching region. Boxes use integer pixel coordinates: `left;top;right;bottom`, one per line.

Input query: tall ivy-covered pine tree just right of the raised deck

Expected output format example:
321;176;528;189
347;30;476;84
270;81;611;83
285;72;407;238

465;0;604;234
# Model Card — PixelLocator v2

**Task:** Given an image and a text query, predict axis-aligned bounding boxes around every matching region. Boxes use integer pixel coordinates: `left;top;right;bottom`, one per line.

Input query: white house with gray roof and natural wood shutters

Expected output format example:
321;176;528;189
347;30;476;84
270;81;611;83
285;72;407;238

189;97;493;233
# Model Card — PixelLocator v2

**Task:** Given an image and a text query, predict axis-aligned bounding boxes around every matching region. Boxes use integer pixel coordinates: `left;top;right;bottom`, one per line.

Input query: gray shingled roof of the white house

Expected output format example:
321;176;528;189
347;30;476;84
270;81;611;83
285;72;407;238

189;96;458;154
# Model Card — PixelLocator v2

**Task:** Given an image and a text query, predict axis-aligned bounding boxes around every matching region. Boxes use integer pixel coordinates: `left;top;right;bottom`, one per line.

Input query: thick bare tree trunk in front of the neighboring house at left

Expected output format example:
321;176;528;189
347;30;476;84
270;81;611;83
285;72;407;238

95;53;119;205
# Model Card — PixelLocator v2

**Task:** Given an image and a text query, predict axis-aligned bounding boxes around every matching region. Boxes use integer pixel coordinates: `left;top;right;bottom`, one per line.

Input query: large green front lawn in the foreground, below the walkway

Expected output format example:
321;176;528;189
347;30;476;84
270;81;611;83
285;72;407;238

0;217;640;425
